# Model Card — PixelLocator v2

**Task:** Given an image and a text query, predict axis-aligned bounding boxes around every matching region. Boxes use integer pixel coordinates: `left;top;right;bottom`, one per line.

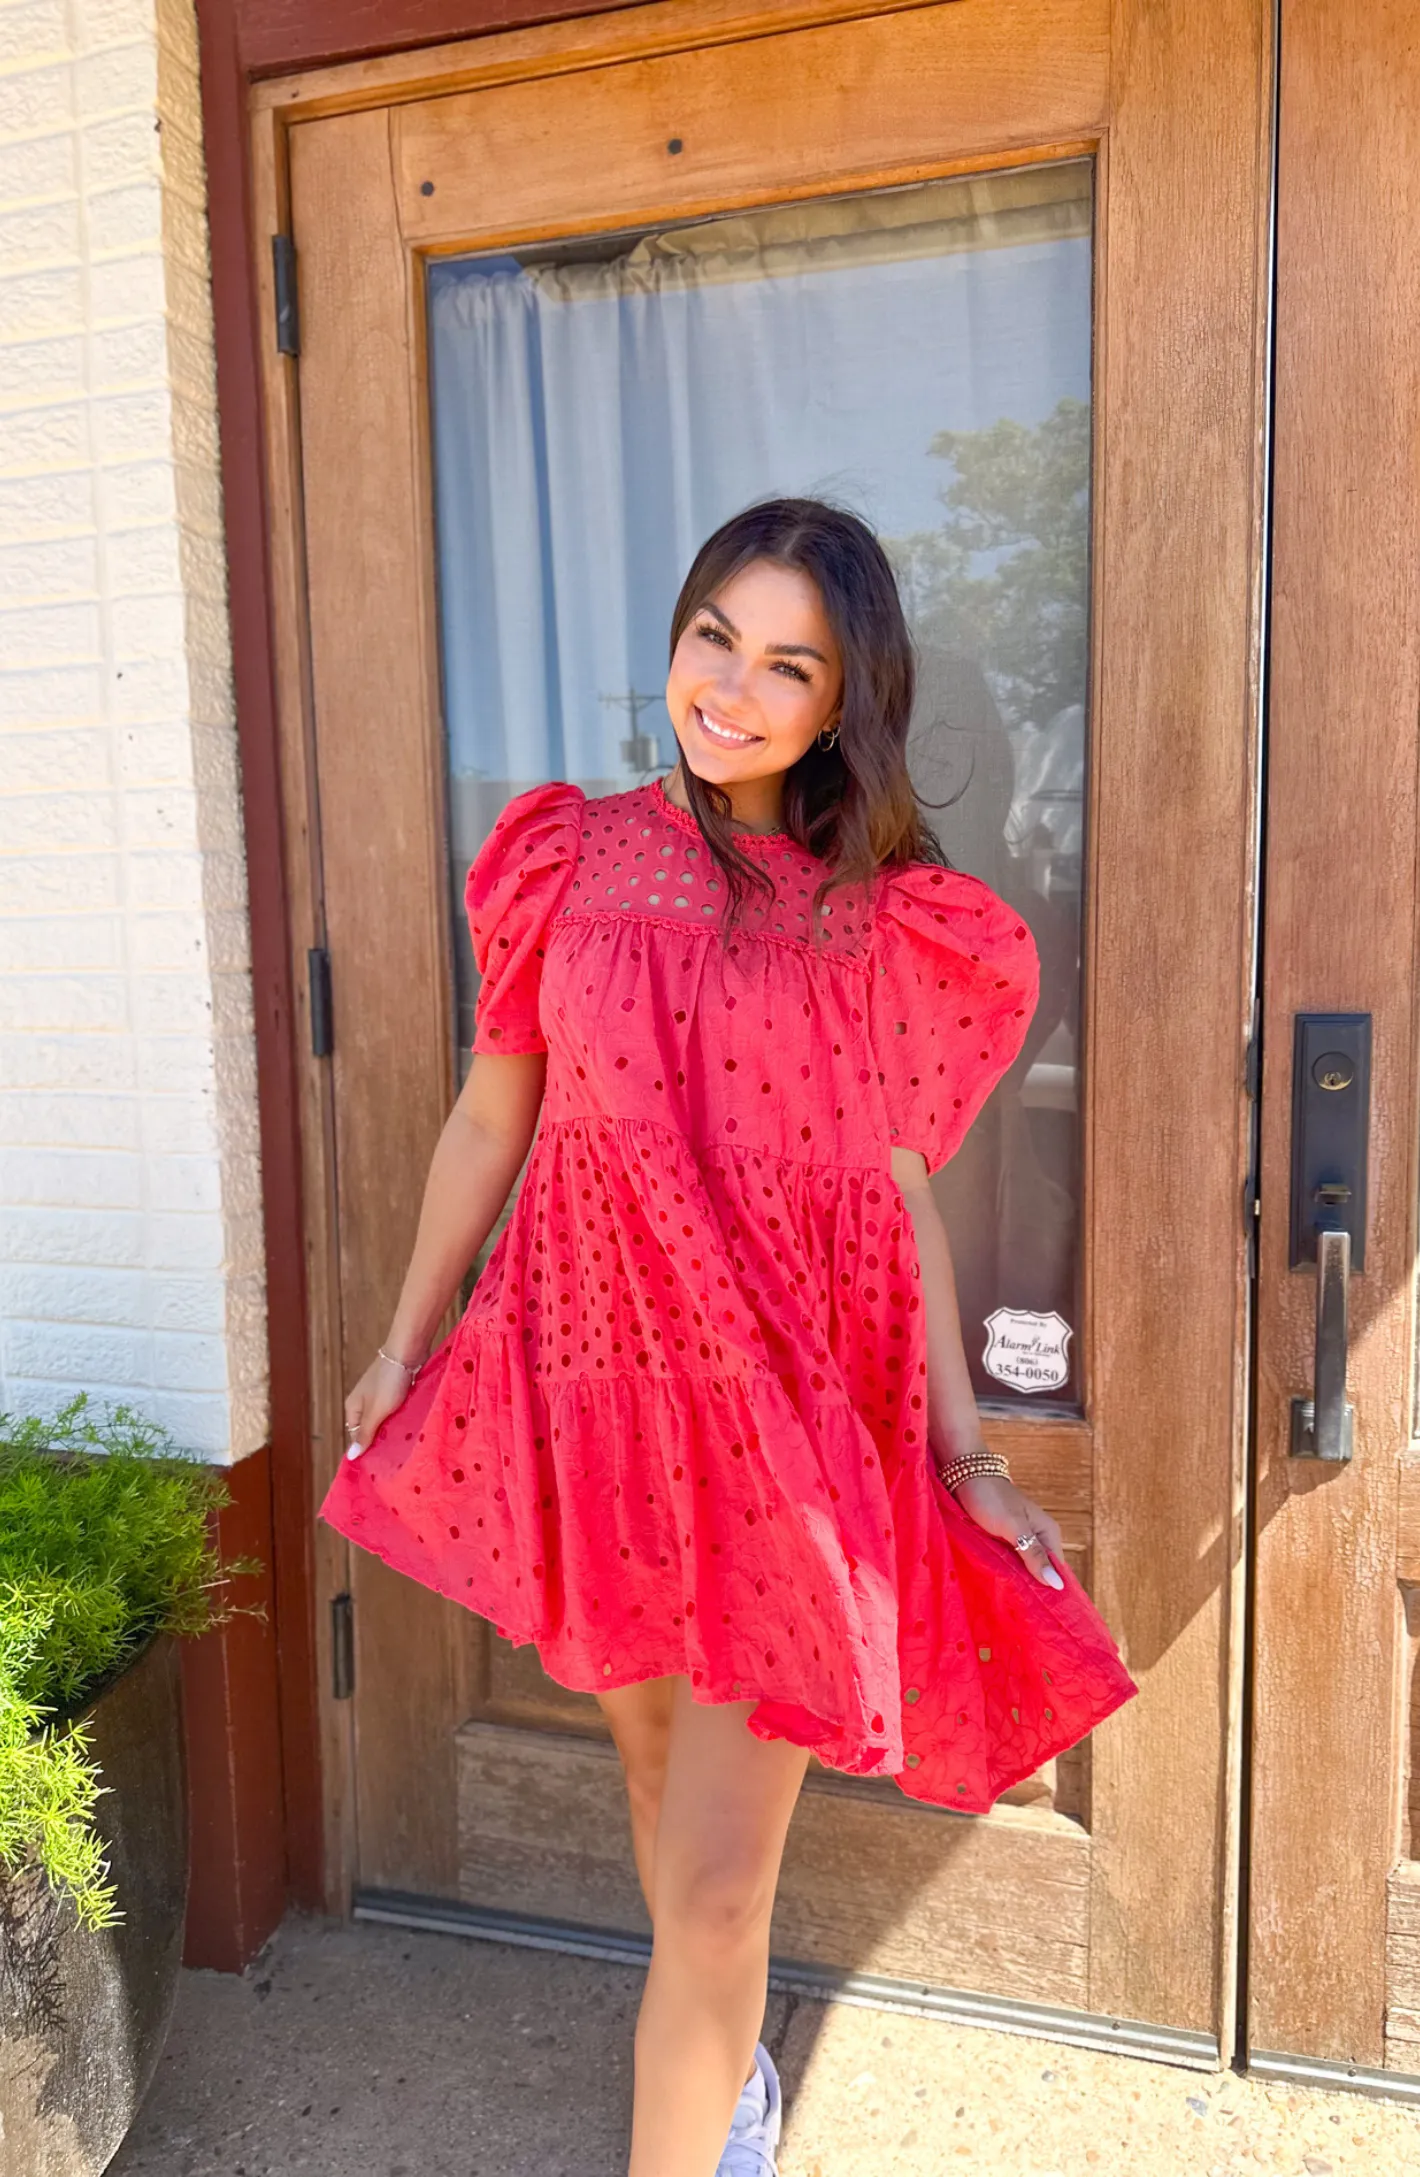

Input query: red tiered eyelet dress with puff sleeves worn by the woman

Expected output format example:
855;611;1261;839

320;782;1135;1811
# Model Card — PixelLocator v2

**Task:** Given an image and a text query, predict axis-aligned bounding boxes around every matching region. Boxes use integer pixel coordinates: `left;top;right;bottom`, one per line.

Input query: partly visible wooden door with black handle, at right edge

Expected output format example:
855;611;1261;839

1248;4;1420;2099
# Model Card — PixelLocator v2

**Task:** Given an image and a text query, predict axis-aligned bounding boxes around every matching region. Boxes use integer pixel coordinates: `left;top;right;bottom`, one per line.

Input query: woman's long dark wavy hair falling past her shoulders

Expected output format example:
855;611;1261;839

671;499;950;930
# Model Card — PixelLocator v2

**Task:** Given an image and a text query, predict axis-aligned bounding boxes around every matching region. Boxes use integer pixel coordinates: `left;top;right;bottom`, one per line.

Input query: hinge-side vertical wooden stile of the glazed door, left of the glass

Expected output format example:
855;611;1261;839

292;113;486;1890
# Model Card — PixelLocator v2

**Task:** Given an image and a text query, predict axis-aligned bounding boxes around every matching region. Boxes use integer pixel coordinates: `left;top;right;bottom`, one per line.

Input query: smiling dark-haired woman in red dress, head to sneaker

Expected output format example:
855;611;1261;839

322;501;1135;2177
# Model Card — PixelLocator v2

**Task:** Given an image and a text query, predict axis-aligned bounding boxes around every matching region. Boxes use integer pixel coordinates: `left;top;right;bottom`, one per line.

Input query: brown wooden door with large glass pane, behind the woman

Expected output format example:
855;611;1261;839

255;0;1270;2064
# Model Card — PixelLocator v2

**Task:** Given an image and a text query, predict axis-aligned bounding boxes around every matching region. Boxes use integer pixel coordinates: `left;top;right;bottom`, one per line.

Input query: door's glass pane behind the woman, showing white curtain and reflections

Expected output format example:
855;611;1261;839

429;161;1091;1404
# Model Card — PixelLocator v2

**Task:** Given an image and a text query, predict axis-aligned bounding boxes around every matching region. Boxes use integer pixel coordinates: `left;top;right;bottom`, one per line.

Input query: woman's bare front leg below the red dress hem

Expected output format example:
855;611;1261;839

629;1678;808;2177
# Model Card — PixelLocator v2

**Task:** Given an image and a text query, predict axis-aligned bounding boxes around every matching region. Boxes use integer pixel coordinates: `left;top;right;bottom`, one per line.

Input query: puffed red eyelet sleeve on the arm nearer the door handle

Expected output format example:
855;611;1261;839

869;862;1039;1171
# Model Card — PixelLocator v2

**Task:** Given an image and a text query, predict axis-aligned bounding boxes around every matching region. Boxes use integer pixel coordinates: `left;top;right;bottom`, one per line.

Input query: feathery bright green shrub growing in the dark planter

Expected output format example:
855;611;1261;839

0;1398;255;1927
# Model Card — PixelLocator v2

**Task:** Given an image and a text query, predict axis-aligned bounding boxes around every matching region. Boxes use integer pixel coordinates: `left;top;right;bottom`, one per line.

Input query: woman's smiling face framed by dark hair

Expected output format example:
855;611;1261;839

666;559;843;786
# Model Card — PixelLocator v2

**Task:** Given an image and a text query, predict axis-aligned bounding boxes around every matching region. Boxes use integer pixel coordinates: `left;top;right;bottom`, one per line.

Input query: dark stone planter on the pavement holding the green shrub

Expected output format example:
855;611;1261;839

0;1639;187;2177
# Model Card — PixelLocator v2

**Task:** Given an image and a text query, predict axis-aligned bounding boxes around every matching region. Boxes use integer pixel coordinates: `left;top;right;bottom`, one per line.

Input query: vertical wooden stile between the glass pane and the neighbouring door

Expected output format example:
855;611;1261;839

1087;0;1270;2046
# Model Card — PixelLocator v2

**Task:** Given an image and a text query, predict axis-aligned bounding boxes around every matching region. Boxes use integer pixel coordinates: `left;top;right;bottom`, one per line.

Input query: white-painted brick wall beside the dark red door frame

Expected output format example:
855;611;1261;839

0;0;266;1459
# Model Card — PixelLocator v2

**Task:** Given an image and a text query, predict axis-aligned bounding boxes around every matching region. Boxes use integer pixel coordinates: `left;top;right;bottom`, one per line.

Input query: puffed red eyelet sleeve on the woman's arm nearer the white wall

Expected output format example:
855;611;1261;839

464;779;586;1054
